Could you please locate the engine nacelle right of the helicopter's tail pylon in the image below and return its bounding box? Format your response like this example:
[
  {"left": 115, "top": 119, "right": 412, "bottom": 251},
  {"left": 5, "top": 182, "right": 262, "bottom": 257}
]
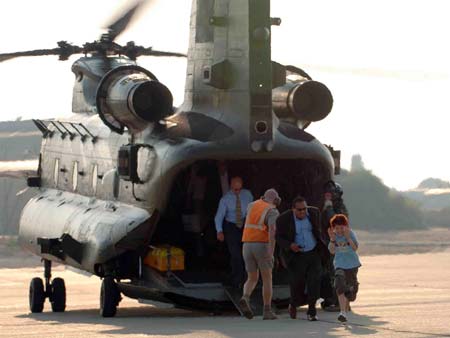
[{"left": 272, "top": 79, "right": 333, "bottom": 125}]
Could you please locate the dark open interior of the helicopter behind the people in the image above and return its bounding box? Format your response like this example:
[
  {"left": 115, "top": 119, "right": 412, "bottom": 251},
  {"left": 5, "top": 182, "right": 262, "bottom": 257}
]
[{"left": 151, "top": 159, "right": 328, "bottom": 283}]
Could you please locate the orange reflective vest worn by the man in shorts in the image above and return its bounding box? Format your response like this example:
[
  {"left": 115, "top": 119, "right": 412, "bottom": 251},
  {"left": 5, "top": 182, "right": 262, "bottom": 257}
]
[{"left": 242, "top": 199, "right": 275, "bottom": 243}]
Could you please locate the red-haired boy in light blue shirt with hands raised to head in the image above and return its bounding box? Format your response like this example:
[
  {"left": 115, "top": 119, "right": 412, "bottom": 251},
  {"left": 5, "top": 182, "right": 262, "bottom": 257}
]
[{"left": 328, "top": 214, "right": 361, "bottom": 323}]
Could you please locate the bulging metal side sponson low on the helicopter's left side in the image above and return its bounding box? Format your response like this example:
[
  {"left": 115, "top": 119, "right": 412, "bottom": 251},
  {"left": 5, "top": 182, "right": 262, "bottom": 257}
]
[{"left": 19, "top": 189, "right": 150, "bottom": 273}]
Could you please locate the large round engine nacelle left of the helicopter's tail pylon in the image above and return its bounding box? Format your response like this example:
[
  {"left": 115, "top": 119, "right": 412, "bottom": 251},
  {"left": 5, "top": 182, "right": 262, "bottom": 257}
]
[{"left": 97, "top": 65, "right": 173, "bottom": 134}]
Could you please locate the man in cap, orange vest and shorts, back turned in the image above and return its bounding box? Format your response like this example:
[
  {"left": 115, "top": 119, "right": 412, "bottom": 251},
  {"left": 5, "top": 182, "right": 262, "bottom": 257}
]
[{"left": 239, "top": 189, "right": 281, "bottom": 319}]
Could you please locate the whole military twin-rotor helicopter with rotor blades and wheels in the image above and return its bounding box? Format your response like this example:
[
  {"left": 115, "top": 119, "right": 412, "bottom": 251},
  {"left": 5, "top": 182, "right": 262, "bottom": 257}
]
[{"left": 0, "top": 0, "right": 340, "bottom": 317}]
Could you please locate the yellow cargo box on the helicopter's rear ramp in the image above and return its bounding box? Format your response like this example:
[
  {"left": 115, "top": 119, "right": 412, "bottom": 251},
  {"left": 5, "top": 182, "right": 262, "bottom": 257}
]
[{"left": 144, "top": 245, "right": 184, "bottom": 271}]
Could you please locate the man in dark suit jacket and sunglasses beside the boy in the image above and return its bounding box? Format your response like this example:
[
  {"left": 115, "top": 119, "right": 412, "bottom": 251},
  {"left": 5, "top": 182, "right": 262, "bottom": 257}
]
[{"left": 276, "top": 196, "right": 328, "bottom": 321}]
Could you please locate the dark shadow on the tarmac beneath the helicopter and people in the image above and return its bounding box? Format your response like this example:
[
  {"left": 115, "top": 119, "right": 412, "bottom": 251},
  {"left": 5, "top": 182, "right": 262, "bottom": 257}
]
[{"left": 17, "top": 306, "right": 386, "bottom": 338}]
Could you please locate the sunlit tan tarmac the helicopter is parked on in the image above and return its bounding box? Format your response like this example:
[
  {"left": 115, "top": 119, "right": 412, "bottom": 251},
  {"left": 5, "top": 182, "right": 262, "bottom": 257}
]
[{"left": 0, "top": 251, "right": 450, "bottom": 338}]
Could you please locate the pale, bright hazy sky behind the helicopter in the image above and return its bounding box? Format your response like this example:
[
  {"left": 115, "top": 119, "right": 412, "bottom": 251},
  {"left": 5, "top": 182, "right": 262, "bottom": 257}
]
[{"left": 0, "top": 0, "right": 450, "bottom": 190}]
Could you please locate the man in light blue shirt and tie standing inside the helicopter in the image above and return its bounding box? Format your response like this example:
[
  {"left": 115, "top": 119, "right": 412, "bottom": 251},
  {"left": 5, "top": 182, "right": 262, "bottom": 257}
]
[{"left": 214, "top": 177, "right": 253, "bottom": 288}]
